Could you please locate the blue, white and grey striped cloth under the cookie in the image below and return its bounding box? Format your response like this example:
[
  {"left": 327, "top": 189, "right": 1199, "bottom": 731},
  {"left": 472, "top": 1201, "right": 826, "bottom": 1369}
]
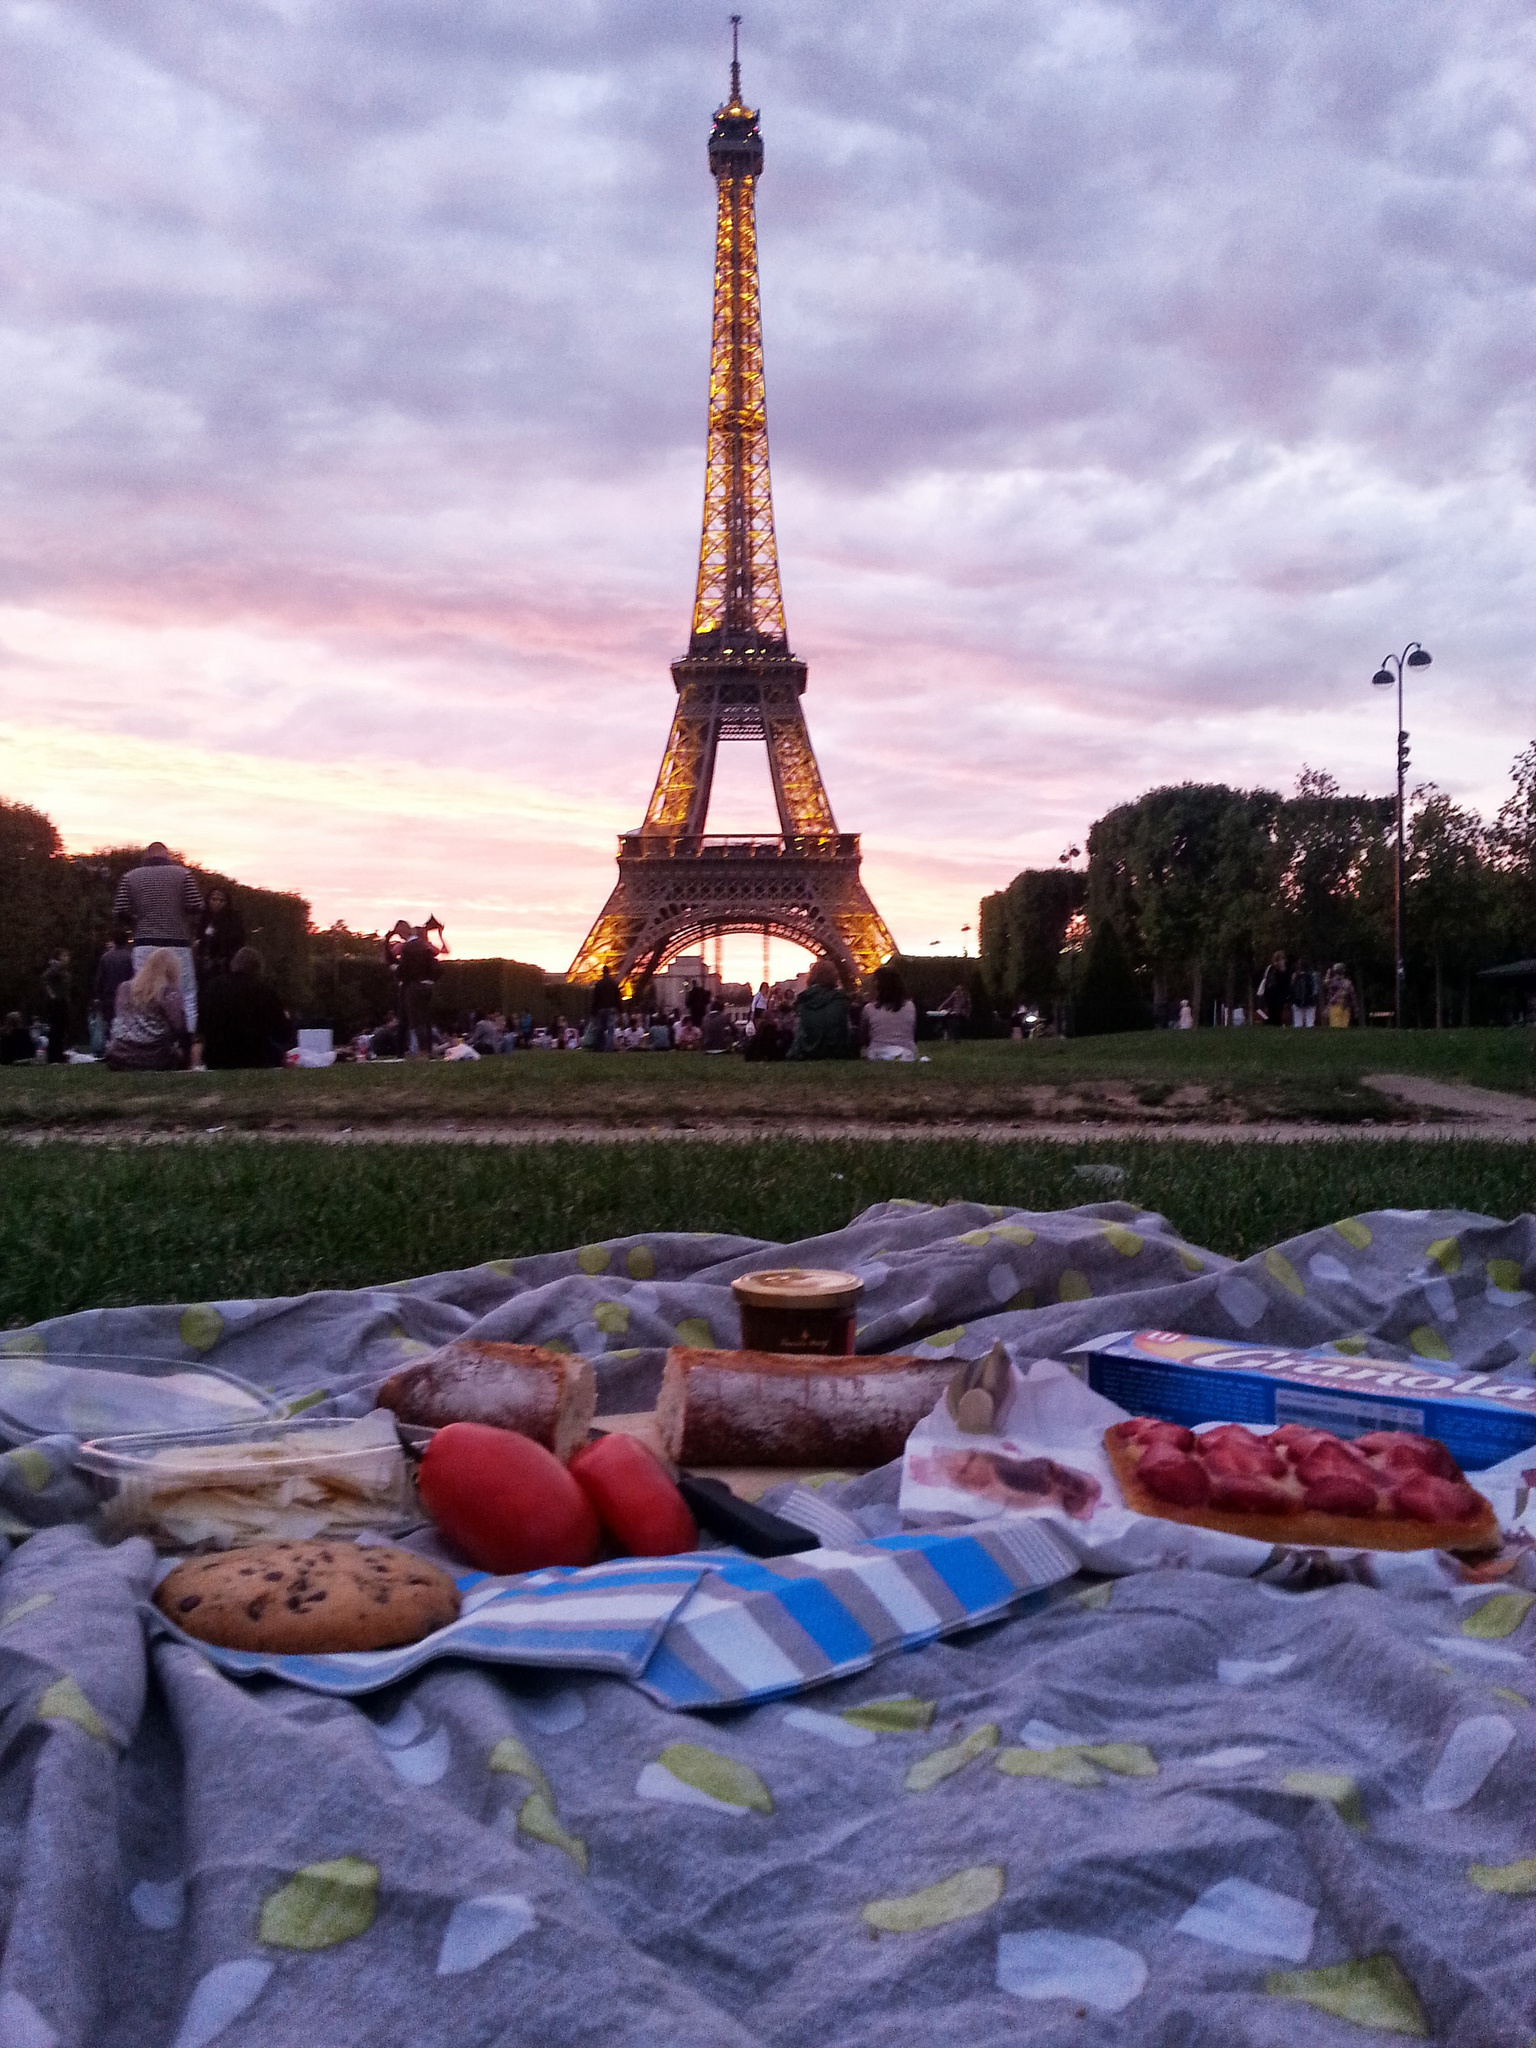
[{"left": 165, "top": 1516, "right": 1077, "bottom": 1708}]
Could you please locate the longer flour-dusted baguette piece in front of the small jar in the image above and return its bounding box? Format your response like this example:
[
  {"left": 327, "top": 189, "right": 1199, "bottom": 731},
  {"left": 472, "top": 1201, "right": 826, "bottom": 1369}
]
[{"left": 655, "top": 1350, "right": 954, "bottom": 1468}]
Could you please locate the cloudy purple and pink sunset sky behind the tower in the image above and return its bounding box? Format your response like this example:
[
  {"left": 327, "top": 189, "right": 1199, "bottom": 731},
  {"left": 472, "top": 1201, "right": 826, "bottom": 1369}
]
[{"left": 0, "top": 0, "right": 1536, "bottom": 967}]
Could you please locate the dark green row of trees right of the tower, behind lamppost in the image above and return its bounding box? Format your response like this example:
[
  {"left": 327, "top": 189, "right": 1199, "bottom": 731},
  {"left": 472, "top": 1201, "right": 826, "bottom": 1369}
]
[{"left": 981, "top": 741, "right": 1536, "bottom": 1030}]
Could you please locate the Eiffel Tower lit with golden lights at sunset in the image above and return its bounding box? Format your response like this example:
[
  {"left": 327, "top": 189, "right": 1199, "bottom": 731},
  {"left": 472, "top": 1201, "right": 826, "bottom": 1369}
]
[{"left": 567, "top": 14, "right": 895, "bottom": 991}]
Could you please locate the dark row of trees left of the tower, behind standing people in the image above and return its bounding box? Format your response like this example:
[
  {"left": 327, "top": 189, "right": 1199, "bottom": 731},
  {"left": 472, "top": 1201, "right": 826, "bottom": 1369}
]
[{"left": 0, "top": 797, "right": 565, "bottom": 1038}]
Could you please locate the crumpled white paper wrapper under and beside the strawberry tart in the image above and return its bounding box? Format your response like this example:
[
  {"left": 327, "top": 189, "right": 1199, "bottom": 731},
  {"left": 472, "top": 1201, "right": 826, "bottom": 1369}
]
[{"left": 901, "top": 1358, "right": 1536, "bottom": 1589}]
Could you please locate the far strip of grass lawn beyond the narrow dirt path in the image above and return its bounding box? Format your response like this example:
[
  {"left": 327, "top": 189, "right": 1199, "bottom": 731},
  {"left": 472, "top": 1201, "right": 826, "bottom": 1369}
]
[{"left": 0, "top": 1030, "right": 1536, "bottom": 1130}]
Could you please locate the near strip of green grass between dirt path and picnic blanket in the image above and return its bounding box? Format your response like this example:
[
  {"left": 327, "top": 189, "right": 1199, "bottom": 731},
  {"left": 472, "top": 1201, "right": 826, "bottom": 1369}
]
[{"left": 0, "top": 1138, "right": 1536, "bottom": 1327}]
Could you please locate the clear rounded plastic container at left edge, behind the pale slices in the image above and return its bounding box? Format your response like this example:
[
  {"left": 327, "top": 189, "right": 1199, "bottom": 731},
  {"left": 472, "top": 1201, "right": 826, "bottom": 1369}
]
[{"left": 0, "top": 1352, "right": 279, "bottom": 1444}]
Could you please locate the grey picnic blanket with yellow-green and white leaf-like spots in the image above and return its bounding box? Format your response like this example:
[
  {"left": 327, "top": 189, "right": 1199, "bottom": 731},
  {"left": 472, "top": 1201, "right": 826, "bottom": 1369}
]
[{"left": 0, "top": 1202, "right": 1536, "bottom": 2048}]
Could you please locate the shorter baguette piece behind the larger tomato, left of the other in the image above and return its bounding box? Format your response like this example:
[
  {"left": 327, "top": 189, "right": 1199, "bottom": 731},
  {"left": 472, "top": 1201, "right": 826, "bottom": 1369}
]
[{"left": 379, "top": 1337, "right": 598, "bottom": 1464}]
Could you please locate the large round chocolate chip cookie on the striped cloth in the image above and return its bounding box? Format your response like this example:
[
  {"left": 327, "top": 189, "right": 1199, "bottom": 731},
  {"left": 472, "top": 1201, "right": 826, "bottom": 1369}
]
[{"left": 156, "top": 1536, "right": 459, "bottom": 1657}]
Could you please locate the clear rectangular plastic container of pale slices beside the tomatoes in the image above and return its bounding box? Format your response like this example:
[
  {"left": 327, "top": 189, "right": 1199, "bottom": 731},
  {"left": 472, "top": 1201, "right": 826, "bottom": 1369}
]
[{"left": 76, "top": 1409, "right": 422, "bottom": 1552}]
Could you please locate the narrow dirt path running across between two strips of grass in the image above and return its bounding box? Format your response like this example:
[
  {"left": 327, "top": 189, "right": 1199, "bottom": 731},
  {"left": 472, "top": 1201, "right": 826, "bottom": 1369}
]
[{"left": 0, "top": 1114, "right": 1536, "bottom": 1147}]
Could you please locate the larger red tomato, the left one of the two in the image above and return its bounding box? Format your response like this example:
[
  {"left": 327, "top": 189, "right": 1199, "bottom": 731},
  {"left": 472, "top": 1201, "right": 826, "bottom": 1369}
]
[{"left": 416, "top": 1421, "right": 602, "bottom": 1573}]
